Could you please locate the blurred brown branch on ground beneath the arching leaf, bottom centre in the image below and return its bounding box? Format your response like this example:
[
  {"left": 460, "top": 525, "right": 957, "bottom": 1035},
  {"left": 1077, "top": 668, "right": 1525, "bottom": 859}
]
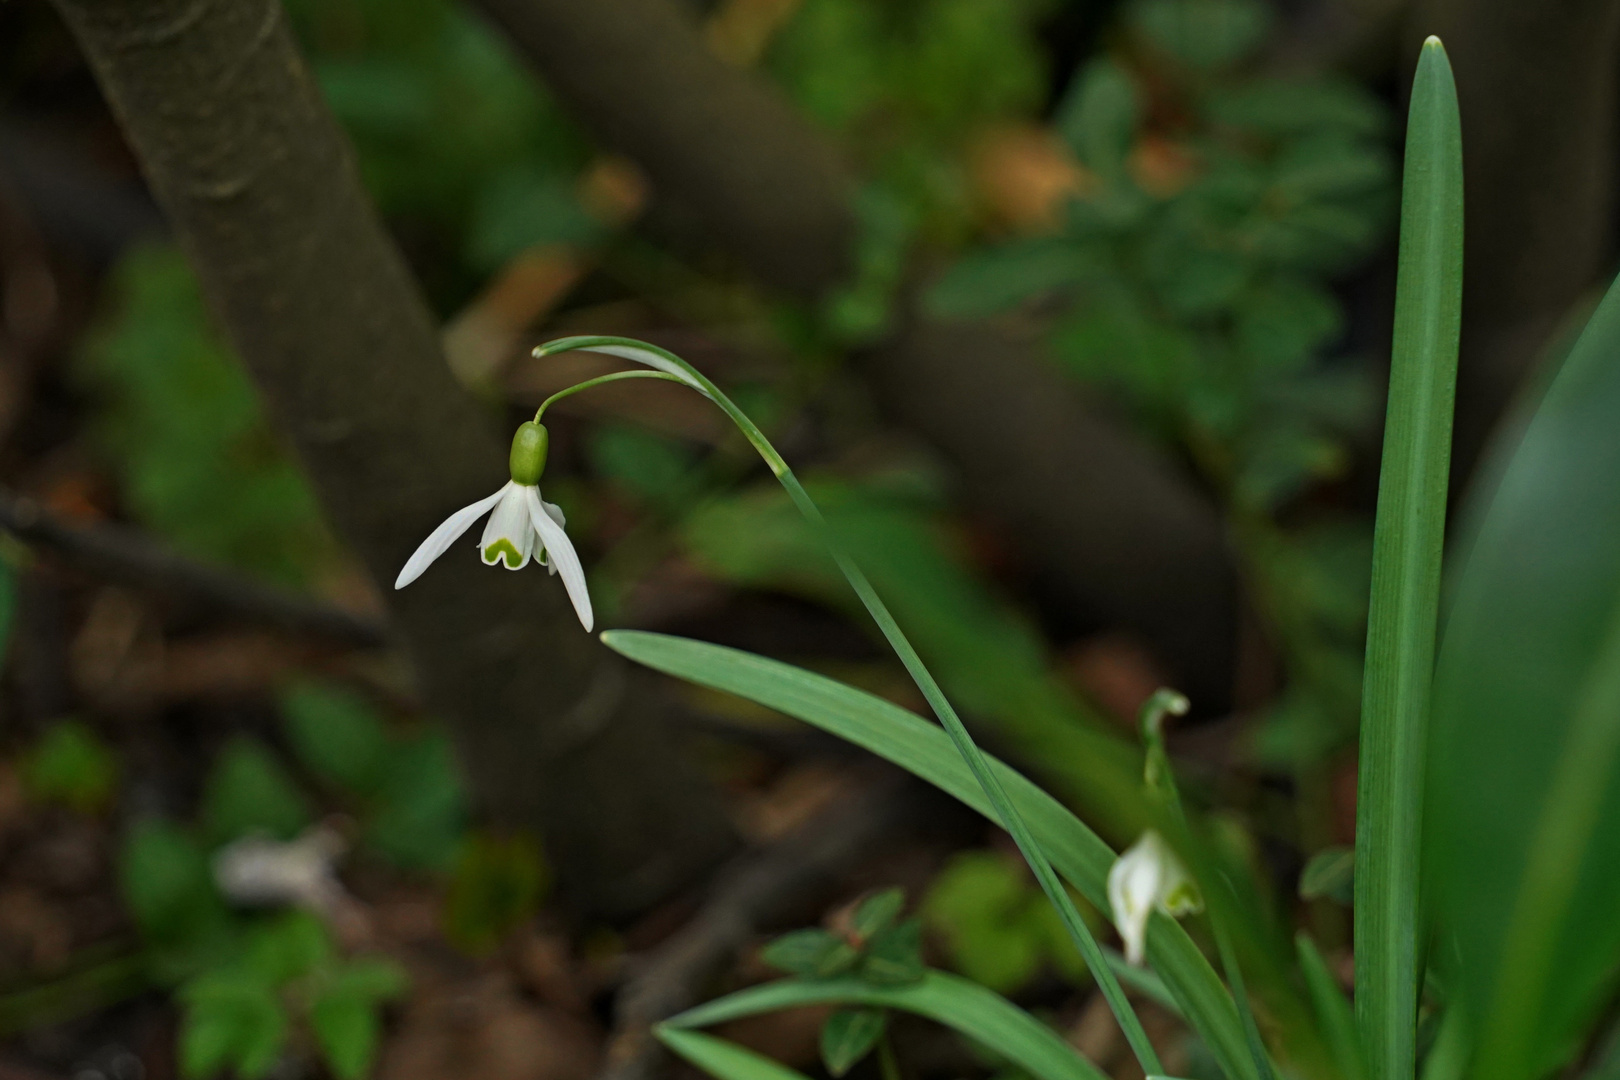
[{"left": 598, "top": 776, "right": 919, "bottom": 1080}]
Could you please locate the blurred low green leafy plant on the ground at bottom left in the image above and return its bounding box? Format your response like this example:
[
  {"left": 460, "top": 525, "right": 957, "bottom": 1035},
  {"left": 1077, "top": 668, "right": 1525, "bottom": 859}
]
[{"left": 122, "top": 683, "right": 443, "bottom": 1080}]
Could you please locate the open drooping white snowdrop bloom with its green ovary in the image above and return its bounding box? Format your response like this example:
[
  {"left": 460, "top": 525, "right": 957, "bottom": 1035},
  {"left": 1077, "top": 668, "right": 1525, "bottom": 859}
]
[{"left": 394, "top": 421, "right": 595, "bottom": 630}]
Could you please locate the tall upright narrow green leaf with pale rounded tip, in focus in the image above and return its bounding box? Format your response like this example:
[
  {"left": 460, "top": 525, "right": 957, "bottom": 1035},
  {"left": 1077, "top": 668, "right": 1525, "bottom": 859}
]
[{"left": 1356, "top": 37, "right": 1463, "bottom": 1080}]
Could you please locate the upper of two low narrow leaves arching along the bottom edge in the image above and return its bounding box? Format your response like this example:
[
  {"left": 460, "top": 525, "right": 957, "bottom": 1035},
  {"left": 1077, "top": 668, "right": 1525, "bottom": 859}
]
[{"left": 666, "top": 972, "right": 1105, "bottom": 1080}]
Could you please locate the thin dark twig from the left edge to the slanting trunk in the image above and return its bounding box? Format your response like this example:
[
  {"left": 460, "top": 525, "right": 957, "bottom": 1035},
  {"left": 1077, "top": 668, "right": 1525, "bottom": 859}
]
[{"left": 0, "top": 489, "right": 390, "bottom": 648}]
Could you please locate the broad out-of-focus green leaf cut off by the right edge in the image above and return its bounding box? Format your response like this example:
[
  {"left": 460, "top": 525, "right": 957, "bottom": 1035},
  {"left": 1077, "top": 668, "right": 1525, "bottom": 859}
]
[{"left": 1426, "top": 270, "right": 1620, "bottom": 1080}]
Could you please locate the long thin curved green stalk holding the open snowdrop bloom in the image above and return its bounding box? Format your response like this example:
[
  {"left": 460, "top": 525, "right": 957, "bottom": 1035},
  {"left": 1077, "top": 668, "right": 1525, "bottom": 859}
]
[{"left": 535, "top": 337, "right": 1165, "bottom": 1077}]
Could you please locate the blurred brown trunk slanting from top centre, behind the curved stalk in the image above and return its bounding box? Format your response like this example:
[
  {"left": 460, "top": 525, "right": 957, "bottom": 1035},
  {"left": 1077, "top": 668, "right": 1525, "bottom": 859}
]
[{"left": 476, "top": 0, "right": 1238, "bottom": 709}]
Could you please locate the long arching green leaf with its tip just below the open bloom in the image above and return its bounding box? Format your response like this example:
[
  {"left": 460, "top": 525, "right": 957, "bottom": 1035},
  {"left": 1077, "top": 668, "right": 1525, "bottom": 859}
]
[{"left": 603, "top": 630, "right": 1256, "bottom": 1080}]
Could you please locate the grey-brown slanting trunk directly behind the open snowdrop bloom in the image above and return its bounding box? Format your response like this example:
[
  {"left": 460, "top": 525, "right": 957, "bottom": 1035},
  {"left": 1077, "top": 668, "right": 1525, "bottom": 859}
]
[{"left": 55, "top": 0, "right": 729, "bottom": 915}]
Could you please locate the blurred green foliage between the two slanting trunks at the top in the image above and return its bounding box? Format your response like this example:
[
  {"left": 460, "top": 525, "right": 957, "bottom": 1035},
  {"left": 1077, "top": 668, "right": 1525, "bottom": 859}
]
[{"left": 287, "top": 0, "right": 604, "bottom": 297}]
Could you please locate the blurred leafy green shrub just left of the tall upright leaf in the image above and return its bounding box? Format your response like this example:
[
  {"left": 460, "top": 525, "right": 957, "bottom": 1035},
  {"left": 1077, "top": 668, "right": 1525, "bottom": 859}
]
[{"left": 930, "top": 0, "right": 1395, "bottom": 771}]
